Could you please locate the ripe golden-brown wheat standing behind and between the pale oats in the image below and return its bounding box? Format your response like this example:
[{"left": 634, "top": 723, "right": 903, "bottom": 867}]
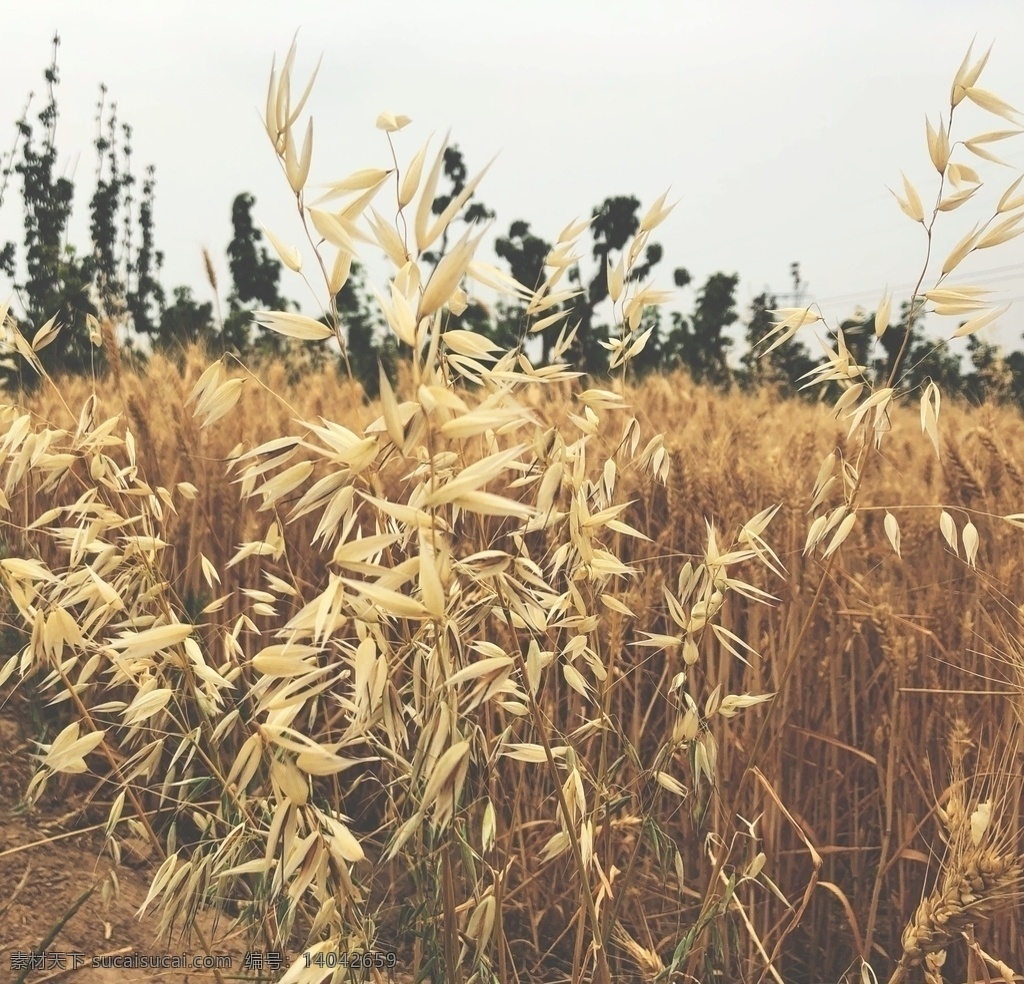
[{"left": 2, "top": 353, "right": 1024, "bottom": 980}]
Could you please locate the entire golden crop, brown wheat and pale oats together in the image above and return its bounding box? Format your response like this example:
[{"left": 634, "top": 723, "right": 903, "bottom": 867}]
[{"left": 0, "top": 30, "right": 1024, "bottom": 984}]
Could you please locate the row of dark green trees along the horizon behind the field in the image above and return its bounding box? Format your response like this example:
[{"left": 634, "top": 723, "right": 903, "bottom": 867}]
[{"left": 0, "top": 37, "right": 1024, "bottom": 408}]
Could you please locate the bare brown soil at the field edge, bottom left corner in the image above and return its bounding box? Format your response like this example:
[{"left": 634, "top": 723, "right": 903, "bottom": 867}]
[{"left": 0, "top": 686, "right": 260, "bottom": 984}]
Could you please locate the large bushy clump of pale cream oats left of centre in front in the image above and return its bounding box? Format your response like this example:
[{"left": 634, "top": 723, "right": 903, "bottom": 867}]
[{"left": 2, "top": 32, "right": 780, "bottom": 984}]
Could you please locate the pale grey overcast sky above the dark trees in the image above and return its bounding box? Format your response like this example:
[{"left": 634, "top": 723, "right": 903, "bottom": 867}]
[{"left": 0, "top": 0, "right": 1024, "bottom": 364}]
